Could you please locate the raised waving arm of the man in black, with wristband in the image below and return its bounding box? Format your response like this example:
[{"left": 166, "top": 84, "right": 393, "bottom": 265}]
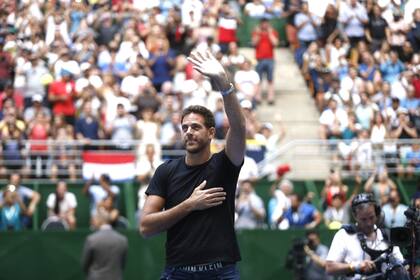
[{"left": 188, "top": 51, "right": 245, "bottom": 166}]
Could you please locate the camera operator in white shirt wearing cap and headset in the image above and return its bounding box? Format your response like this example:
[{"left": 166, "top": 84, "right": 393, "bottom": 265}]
[{"left": 326, "top": 193, "right": 403, "bottom": 279}]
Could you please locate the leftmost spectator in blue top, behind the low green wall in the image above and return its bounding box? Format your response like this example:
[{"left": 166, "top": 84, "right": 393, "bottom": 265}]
[{"left": 0, "top": 185, "right": 26, "bottom": 231}]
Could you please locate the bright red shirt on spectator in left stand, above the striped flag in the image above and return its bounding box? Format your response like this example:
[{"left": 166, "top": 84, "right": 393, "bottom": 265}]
[{"left": 49, "top": 80, "right": 76, "bottom": 116}]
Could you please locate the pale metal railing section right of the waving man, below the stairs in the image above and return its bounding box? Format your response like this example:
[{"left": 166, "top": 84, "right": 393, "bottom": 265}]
[{"left": 258, "top": 138, "right": 420, "bottom": 179}]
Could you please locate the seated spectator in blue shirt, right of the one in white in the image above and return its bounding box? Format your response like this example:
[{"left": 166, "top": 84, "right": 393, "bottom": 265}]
[{"left": 279, "top": 194, "right": 321, "bottom": 229}]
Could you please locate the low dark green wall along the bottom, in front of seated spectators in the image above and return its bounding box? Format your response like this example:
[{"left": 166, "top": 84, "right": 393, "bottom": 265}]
[{"left": 0, "top": 230, "right": 334, "bottom": 280}]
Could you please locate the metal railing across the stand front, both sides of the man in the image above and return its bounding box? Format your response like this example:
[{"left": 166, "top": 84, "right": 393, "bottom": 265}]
[{"left": 0, "top": 139, "right": 420, "bottom": 182}]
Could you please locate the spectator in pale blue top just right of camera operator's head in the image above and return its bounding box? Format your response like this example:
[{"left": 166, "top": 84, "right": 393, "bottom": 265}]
[{"left": 382, "top": 190, "right": 408, "bottom": 228}]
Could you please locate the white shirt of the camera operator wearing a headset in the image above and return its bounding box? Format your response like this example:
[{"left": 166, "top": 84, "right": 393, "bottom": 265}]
[{"left": 326, "top": 229, "right": 403, "bottom": 279}]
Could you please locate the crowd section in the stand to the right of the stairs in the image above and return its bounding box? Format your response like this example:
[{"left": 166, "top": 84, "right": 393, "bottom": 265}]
[{"left": 287, "top": 0, "right": 420, "bottom": 177}]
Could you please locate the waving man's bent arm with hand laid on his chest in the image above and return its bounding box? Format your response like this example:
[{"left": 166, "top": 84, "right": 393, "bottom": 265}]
[{"left": 139, "top": 181, "right": 226, "bottom": 237}]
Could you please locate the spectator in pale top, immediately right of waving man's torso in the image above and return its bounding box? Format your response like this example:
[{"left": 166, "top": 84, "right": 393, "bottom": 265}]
[{"left": 235, "top": 181, "right": 265, "bottom": 229}]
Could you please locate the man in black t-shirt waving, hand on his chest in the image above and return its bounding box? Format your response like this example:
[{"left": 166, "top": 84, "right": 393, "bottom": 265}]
[{"left": 140, "top": 51, "right": 245, "bottom": 279}]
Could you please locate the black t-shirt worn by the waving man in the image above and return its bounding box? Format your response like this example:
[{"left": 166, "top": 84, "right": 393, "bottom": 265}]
[{"left": 146, "top": 150, "right": 241, "bottom": 265}]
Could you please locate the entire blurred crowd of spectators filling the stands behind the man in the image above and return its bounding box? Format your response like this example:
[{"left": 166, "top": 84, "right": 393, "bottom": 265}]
[{"left": 0, "top": 0, "right": 420, "bottom": 232}]
